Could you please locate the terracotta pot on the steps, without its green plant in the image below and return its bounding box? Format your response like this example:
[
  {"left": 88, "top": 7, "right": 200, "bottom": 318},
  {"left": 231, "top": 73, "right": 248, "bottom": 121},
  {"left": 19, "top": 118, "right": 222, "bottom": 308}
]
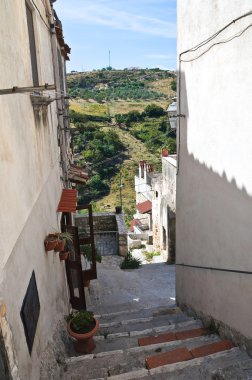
[{"left": 67, "top": 318, "right": 99, "bottom": 354}]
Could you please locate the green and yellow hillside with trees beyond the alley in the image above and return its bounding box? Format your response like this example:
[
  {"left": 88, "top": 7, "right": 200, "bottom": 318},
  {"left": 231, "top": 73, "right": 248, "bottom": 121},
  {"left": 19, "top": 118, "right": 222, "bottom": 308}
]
[{"left": 68, "top": 69, "right": 176, "bottom": 222}]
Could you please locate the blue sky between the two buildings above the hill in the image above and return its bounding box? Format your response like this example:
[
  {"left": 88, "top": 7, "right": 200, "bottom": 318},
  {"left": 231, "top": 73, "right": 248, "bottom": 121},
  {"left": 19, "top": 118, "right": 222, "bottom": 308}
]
[{"left": 54, "top": 0, "right": 176, "bottom": 72}]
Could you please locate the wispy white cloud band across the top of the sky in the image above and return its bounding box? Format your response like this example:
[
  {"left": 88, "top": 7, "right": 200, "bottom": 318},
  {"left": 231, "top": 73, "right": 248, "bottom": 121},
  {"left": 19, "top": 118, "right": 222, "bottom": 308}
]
[{"left": 56, "top": 0, "right": 176, "bottom": 38}]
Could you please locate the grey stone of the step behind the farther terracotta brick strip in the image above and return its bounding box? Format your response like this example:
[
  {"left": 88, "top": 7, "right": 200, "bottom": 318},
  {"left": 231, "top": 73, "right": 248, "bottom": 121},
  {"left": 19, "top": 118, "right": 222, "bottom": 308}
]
[{"left": 93, "top": 320, "right": 202, "bottom": 353}]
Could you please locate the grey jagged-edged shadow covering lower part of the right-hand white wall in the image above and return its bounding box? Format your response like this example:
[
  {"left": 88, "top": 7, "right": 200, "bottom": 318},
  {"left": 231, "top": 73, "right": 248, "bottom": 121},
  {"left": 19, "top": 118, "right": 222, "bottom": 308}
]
[{"left": 176, "top": 69, "right": 252, "bottom": 344}]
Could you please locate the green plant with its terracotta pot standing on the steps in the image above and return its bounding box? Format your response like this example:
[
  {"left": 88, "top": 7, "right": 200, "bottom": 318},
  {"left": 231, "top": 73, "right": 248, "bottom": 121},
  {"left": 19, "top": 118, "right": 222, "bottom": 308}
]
[{"left": 65, "top": 310, "right": 99, "bottom": 354}]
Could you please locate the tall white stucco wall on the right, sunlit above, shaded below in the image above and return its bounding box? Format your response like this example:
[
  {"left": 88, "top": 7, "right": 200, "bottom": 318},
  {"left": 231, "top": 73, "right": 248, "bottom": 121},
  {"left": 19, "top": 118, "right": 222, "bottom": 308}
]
[{"left": 176, "top": 0, "right": 252, "bottom": 338}]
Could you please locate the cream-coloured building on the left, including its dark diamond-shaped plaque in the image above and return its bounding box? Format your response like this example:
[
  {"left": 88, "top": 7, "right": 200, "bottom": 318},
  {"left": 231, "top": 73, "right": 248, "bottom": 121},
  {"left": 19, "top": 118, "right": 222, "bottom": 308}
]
[{"left": 0, "top": 0, "right": 71, "bottom": 380}]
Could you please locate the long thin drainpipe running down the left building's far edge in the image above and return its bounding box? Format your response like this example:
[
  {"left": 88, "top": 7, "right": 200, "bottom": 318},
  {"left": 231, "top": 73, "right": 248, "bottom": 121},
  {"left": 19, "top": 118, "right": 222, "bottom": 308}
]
[{"left": 45, "top": 0, "right": 67, "bottom": 186}]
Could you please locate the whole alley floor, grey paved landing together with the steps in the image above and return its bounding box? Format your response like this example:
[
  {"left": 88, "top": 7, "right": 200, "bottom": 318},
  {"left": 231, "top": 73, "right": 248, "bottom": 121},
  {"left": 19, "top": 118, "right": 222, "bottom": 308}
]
[{"left": 63, "top": 256, "right": 252, "bottom": 380}]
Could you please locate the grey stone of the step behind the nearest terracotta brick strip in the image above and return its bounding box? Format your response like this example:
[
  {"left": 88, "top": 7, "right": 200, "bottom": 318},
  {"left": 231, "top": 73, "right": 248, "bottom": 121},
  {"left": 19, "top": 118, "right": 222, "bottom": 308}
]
[{"left": 63, "top": 335, "right": 220, "bottom": 380}]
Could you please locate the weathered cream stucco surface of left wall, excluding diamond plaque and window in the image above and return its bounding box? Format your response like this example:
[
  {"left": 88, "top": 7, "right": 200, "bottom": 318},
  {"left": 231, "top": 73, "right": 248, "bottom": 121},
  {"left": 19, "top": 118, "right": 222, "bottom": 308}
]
[{"left": 0, "top": 0, "right": 68, "bottom": 380}]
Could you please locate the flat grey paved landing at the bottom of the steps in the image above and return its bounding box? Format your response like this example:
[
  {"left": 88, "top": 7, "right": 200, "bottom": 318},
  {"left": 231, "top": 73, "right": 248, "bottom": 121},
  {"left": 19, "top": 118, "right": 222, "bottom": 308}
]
[{"left": 87, "top": 256, "right": 175, "bottom": 314}]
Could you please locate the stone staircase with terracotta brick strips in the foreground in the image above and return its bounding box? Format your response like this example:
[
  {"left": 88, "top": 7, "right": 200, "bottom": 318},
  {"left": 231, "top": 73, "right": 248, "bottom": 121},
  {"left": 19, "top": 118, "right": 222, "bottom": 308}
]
[{"left": 63, "top": 306, "right": 252, "bottom": 380}]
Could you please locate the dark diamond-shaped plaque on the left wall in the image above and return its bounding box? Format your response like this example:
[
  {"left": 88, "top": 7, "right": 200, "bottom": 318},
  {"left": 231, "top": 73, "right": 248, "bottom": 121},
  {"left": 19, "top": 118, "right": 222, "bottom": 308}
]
[{"left": 20, "top": 271, "right": 40, "bottom": 354}]
